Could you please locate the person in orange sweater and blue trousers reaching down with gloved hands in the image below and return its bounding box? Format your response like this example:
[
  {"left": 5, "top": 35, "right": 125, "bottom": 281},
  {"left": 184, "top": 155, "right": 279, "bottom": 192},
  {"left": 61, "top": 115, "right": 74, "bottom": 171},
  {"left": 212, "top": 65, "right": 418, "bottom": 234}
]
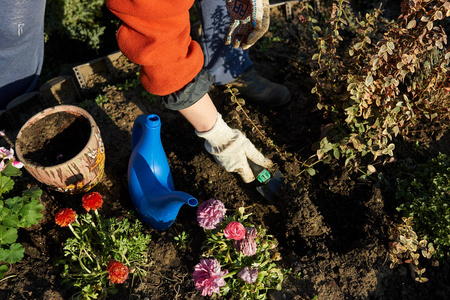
[{"left": 106, "top": 0, "right": 291, "bottom": 182}]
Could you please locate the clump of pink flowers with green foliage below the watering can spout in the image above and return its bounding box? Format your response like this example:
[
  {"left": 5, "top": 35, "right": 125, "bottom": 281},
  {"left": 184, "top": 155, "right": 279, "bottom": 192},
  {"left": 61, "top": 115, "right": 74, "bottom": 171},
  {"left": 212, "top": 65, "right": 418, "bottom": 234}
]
[{"left": 193, "top": 199, "right": 283, "bottom": 299}]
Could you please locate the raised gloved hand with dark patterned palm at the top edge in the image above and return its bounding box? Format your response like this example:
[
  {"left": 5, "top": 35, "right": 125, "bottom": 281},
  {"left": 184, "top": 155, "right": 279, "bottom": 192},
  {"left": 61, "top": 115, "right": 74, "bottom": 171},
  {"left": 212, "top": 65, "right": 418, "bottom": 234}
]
[{"left": 225, "top": 0, "right": 270, "bottom": 50}]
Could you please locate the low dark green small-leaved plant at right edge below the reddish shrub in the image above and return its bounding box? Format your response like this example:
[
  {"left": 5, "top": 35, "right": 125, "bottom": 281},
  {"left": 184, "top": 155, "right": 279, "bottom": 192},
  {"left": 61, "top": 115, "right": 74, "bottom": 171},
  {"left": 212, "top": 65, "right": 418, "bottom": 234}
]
[{"left": 396, "top": 153, "right": 450, "bottom": 259}]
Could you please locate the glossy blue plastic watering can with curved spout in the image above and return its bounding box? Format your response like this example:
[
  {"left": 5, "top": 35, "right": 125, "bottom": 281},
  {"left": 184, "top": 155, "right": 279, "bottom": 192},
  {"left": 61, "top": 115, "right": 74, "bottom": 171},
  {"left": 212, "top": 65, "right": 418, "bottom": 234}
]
[{"left": 128, "top": 114, "right": 198, "bottom": 230}]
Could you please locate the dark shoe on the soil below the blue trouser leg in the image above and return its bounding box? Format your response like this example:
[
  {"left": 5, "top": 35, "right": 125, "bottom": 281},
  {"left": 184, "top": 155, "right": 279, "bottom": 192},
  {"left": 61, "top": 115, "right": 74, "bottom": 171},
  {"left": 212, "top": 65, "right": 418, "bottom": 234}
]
[{"left": 230, "top": 66, "right": 291, "bottom": 107}]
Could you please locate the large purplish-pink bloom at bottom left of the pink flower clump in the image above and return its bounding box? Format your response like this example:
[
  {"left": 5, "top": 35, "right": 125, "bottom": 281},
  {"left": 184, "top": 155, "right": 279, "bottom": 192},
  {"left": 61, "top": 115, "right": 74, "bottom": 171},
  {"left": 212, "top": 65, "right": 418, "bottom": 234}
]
[{"left": 192, "top": 258, "right": 228, "bottom": 296}]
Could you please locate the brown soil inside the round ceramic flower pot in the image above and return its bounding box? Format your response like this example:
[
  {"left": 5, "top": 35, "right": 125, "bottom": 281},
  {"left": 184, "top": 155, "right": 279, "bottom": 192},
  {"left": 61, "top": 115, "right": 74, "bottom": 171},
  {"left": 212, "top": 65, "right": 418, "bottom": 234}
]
[{"left": 18, "top": 112, "right": 91, "bottom": 167}]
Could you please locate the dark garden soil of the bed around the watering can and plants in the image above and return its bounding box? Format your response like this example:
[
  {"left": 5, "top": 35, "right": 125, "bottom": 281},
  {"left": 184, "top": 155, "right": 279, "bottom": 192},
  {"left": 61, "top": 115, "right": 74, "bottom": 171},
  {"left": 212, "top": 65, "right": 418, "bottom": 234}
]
[{"left": 0, "top": 2, "right": 450, "bottom": 300}]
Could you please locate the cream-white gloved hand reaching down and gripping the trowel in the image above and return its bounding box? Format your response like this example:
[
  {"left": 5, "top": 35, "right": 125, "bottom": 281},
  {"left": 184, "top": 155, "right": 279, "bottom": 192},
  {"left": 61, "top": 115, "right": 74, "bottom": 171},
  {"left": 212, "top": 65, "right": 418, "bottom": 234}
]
[{"left": 195, "top": 113, "right": 272, "bottom": 183}]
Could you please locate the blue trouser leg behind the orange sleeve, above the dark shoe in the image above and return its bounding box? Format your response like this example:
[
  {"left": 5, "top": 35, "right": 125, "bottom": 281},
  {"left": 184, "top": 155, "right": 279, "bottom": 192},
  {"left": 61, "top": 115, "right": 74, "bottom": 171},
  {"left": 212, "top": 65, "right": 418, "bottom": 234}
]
[{"left": 196, "top": 0, "right": 252, "bottom": 85}]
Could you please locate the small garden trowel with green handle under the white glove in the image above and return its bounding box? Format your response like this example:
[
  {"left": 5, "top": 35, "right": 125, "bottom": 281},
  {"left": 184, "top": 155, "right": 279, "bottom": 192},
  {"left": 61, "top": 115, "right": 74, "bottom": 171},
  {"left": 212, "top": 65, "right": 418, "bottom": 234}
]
[{"left": 247, "top": 159, "right": 284, "bottom": 204}]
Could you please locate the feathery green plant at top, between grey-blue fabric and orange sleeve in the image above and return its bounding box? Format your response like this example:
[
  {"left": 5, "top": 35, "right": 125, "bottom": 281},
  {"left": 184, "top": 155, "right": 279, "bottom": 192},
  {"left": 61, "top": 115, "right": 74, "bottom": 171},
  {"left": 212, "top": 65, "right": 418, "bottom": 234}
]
[{"left": 44, "top": 0, "right": 105, "bottom": 49}]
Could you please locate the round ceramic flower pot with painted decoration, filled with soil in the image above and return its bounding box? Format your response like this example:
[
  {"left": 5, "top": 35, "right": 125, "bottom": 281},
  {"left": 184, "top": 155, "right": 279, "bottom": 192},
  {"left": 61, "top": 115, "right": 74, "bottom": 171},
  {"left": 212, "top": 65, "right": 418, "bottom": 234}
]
[{"left": 16, "top": 105, "right": 105, "bottom": 194}]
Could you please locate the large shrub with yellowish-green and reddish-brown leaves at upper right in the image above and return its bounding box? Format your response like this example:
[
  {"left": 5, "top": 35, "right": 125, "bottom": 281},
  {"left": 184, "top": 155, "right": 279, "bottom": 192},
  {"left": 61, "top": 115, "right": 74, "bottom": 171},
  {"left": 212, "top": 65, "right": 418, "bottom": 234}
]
[{"left": 304, "top": 0, "right": 450, "bottom": 169}]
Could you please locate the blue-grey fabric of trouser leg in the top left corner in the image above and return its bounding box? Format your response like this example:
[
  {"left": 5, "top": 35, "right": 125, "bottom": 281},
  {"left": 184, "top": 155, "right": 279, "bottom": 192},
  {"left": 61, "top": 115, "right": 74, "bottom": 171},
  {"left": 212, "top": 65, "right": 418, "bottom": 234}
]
[{"left": 0, "top": 0, "right": 45, "bottom": 109}]
